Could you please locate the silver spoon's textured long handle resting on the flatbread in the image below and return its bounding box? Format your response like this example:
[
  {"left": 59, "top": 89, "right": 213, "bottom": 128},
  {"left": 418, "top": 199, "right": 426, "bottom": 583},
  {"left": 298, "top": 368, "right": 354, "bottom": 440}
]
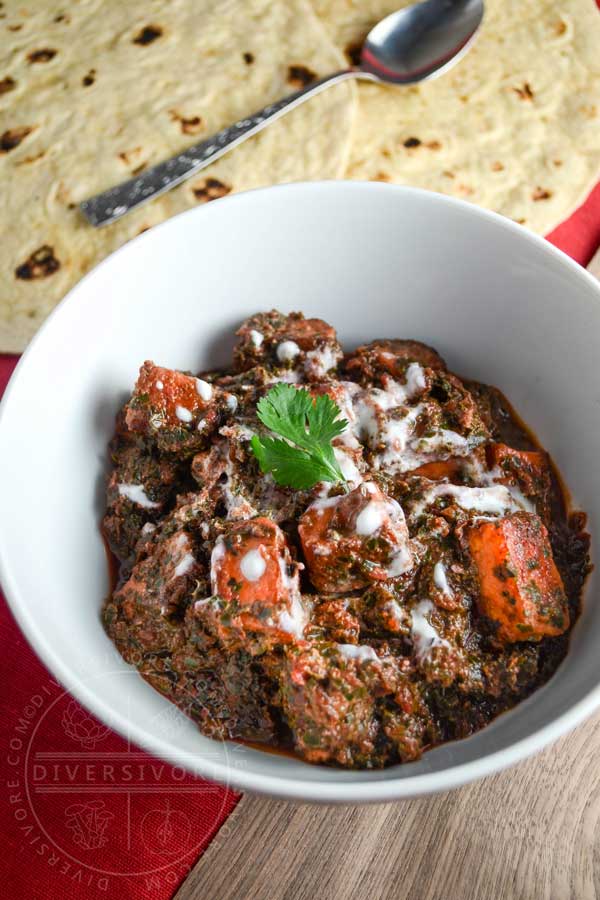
[{"left": 79, "top": 69, "right": 360, "bottom": 227}]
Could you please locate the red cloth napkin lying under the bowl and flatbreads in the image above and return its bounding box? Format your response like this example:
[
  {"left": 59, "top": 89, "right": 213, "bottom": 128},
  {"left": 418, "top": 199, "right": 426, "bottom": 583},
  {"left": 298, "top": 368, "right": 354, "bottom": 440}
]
[{"left": 0, "top": 179, "right": 600, "bottom": 900}]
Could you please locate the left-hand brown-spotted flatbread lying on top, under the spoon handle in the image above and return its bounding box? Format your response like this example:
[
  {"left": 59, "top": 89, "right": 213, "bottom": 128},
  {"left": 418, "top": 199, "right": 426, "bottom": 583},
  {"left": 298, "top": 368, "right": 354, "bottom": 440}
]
[{"left": 0, "top": 0, "right": 355, "bottom": 351}]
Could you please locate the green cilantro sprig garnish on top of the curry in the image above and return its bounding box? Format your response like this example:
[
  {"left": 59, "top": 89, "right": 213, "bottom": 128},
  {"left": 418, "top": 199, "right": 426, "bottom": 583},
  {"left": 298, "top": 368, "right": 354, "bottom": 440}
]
[{"left": 251, "top": 384, "right": 348, "bottom": 490}]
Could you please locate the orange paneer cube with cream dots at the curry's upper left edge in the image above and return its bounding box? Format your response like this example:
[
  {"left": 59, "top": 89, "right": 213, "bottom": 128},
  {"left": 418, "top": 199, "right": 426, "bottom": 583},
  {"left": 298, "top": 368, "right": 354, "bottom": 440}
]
[{"left": 126, "top": 362, "right": 229, "bottom": 450}]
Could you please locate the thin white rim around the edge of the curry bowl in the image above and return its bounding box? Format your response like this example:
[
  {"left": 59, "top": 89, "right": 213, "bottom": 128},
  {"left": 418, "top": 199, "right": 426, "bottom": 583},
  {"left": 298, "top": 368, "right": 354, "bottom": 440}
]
[{"left": 0, "top": 180, "right": 600, "bottom": 804}]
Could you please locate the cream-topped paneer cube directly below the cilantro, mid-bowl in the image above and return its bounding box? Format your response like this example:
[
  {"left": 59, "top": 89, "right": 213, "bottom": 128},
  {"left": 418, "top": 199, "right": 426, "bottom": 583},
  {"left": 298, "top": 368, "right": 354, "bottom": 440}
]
[{"left": 298, "top": 482, "right": 413, "bottom": 593}]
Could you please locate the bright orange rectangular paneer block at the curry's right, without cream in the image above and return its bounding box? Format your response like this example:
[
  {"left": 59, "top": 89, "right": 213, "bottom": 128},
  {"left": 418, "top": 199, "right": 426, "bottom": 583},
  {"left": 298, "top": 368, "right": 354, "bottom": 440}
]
[{"left": 468, "top": 512, "right": 569, "bottom": 643}]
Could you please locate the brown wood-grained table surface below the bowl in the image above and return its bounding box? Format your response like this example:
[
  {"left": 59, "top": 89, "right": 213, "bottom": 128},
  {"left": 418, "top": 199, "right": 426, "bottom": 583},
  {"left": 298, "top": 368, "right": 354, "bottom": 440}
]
[{"left": 175, "top": 251, "right": 600, "bottom": 900}]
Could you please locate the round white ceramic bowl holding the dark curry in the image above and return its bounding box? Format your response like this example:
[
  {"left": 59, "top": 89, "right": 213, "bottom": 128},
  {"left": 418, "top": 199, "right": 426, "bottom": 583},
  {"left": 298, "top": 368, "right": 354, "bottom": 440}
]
[{"left": 0, "top": 182, "right": 600, "bottom": 803}]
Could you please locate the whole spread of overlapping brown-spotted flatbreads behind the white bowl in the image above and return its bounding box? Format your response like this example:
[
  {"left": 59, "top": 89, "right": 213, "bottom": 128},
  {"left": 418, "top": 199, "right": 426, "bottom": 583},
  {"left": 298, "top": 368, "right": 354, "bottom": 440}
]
[{"left": 0, "top": 0, "right": 600, "bottom": 351}]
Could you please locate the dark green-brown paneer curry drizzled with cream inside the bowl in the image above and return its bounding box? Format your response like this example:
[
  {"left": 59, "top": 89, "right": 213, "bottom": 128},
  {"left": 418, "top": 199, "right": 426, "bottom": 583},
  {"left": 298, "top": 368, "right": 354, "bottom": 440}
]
[{"left": 103, "top": 311, "right": 590, "bottom": 768}]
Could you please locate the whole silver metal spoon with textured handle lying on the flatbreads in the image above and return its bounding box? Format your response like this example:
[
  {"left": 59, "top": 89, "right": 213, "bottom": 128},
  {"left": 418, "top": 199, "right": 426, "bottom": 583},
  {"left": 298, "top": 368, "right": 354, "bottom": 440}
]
[{"left": 80, "top": 0, "right": 483, "bottom": 226}]
